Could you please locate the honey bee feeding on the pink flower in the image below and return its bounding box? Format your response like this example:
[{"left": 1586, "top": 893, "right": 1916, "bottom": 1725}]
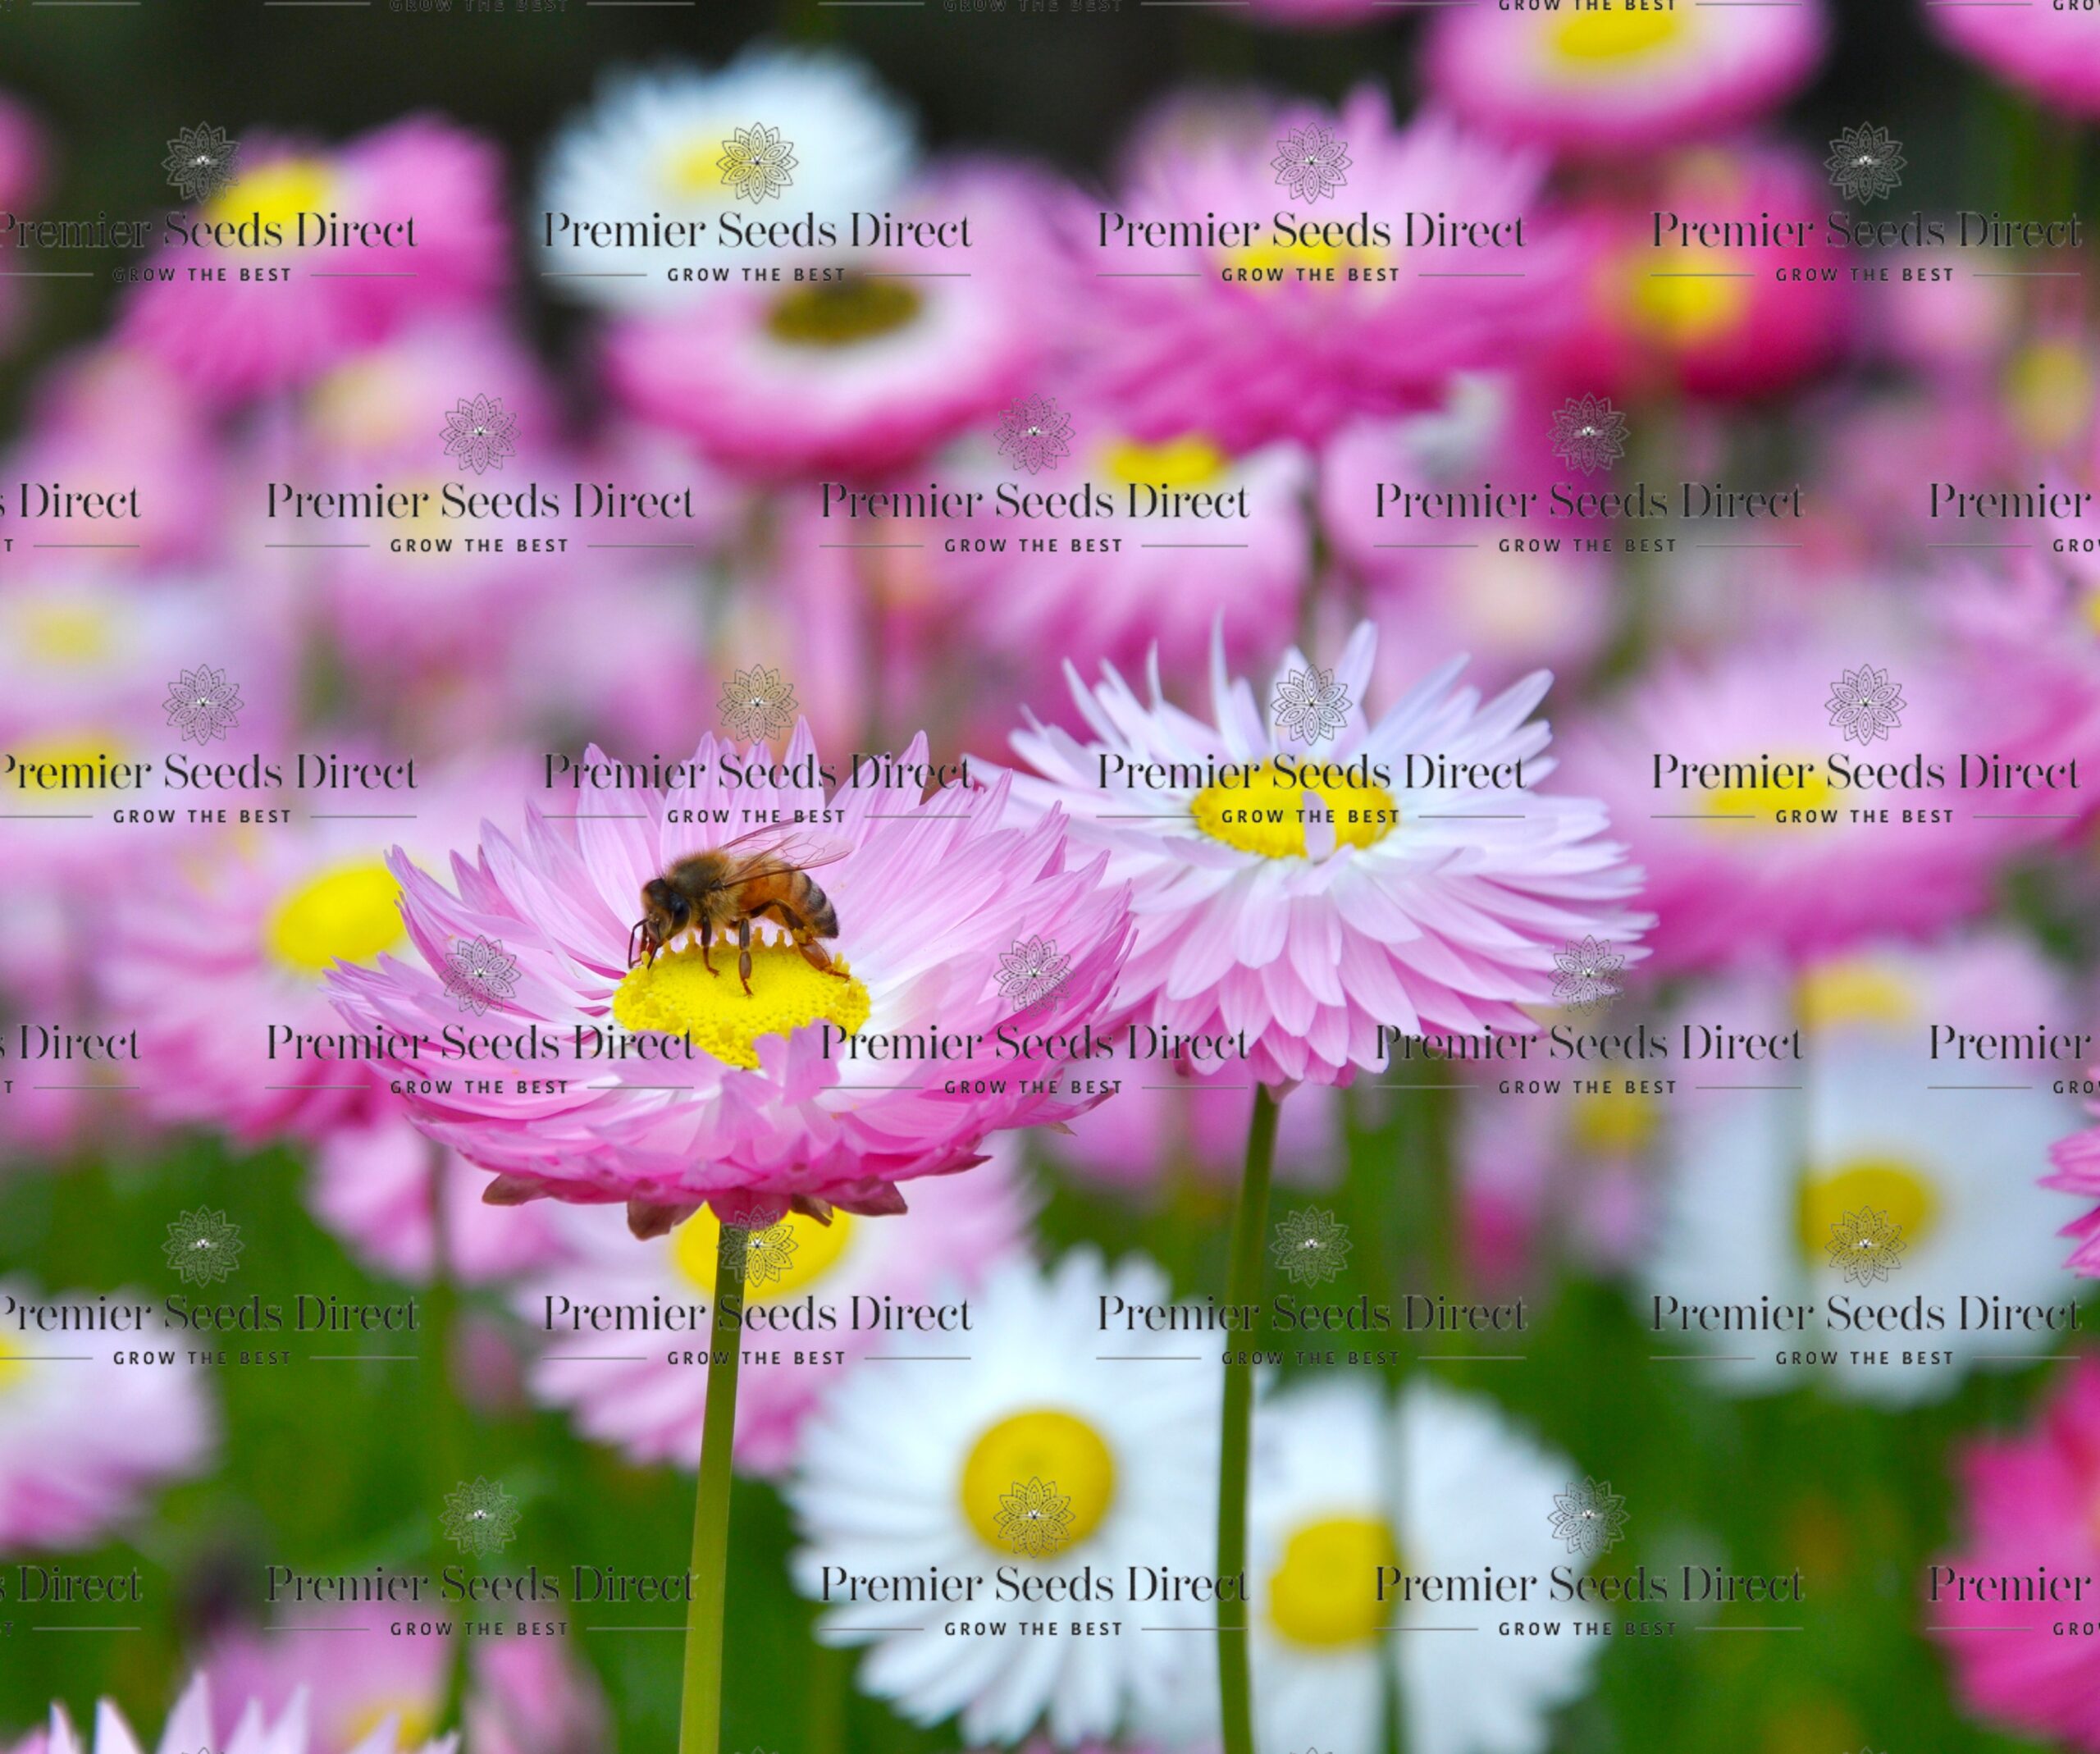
[{"left": 628, "top": 824, "right": 852, "bottom": 993}]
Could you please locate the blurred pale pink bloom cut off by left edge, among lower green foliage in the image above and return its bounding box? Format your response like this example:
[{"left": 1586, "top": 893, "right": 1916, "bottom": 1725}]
[{"left": 0, "top": 1279, "right": 217, "bottom": 1548}]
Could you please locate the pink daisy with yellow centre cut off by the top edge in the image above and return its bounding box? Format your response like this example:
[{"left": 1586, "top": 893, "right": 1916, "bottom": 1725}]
[{"left": 1424, "top": 0, "right": 1829, "bottom": 158}]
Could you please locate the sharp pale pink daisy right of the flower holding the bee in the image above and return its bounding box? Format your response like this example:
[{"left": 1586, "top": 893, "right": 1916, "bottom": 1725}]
[{"left": 1012, "top": 622, "right": 1649, "bottom": 1084}]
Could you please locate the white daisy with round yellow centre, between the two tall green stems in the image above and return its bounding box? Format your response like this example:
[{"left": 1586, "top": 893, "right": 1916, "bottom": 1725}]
[{"left": 788, "top": 1249, "right": 1220, "bottom": 1743}]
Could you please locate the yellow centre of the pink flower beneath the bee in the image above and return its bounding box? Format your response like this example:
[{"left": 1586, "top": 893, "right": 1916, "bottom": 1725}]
[{"left": 614, "top": 943, "right": 874, "bottom": 1071}]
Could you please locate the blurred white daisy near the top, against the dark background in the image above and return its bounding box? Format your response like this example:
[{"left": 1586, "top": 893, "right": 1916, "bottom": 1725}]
[{"left": 536, "top": 48, "right": 915, "bottom": 308}]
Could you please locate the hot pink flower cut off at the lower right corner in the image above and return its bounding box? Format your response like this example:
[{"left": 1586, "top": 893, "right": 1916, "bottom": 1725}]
[{"left": 1930, "top": 1357, "right": 2100, "bottom": 1750}]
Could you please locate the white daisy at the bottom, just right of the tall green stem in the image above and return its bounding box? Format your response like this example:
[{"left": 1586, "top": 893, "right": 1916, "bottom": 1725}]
[{"left": 1248, "top": 1376, "right": 1600, "bottom": 1754}]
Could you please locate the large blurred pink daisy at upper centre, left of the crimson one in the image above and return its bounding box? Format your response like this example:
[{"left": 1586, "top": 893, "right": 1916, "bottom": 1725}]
[{"left": 1065, "top": 86, "right": 1567, "bottom": 452}]
